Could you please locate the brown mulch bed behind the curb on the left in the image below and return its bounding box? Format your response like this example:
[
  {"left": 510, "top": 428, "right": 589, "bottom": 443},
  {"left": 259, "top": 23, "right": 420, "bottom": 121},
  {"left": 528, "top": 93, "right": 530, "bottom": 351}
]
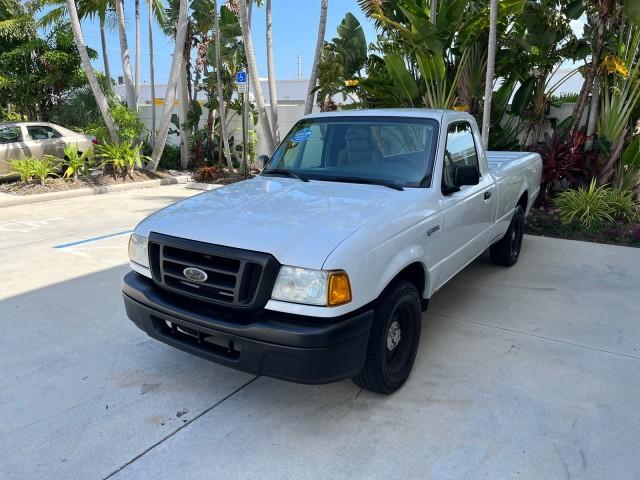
[{"left": 0, "top": 171, "right": 173, "bottom": 195}]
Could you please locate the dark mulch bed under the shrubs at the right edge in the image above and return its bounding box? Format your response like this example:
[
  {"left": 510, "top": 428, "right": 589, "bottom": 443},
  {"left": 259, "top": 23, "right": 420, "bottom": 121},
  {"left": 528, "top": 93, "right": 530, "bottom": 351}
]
[{"left": 525, "top": 206, "right": 640, "bottom": 247}]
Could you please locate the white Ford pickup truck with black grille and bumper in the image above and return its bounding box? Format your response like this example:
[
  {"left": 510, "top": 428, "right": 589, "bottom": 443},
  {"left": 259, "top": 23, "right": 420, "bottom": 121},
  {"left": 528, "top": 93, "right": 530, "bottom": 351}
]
[{"left": 123, "top": 109, "right": 542, "bottom": 393}]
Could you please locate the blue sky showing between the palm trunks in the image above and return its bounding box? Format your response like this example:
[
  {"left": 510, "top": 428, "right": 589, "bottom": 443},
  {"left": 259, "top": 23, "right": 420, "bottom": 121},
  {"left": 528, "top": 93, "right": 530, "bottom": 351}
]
[{"left": 70, "top": 0, "right": 375, "bottom": 83}]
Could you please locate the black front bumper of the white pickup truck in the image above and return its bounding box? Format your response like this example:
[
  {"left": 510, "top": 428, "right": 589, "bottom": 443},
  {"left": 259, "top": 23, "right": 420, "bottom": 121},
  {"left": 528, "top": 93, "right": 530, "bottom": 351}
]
[{"left": 122, "top": 272, "right": 373, "bottom": 384}]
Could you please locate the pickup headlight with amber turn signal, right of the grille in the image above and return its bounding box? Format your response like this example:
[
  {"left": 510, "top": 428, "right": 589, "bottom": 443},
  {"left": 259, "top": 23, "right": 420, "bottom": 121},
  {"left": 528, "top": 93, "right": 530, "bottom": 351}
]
[{"left": 271, "top": 266, "right": 351, "bottom": 307}]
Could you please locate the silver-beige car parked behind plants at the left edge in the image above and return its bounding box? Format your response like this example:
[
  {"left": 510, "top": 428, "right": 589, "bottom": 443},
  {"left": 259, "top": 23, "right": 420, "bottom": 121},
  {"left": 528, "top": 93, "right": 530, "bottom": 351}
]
[{"left": 0, "top": 122, "right": 94, "bottom": 177}]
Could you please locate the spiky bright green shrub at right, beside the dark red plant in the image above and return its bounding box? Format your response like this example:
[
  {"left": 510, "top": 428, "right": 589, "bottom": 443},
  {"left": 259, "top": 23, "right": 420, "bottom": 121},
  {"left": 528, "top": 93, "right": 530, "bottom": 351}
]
[{"left": 554, "top": 179, "right": 637, "bottom": 229}]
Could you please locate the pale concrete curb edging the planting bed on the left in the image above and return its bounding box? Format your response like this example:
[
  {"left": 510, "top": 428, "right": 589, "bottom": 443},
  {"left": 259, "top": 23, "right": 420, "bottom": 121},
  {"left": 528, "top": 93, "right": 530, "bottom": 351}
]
[{"left": 0, "top": 175, "right": 190, "bottom": 208}]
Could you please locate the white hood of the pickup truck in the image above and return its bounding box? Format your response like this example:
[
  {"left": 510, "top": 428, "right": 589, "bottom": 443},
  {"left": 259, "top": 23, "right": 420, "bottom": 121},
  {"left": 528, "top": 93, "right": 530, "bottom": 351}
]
[{"left": 136, "top": 177, "right": 415, "bottom": 269}]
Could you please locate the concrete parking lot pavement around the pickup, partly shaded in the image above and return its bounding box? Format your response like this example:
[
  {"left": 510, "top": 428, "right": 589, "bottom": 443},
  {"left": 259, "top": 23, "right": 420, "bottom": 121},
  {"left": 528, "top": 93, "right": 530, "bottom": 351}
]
[{"left": 0, "top": 186, "right": 640, "bottom": 480}]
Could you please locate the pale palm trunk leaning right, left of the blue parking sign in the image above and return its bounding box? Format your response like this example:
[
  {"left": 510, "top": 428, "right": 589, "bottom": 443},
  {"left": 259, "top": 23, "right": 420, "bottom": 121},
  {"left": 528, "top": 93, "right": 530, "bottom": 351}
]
[{"left": 148, "top": 0, "right": 188, "bottom": 171}]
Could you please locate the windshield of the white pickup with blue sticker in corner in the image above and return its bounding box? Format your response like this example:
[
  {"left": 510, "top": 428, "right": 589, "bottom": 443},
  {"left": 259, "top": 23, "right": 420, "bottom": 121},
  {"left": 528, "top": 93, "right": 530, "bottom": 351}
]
[{"left": 263, "top": 117, "right": 438, "bottom": 187}]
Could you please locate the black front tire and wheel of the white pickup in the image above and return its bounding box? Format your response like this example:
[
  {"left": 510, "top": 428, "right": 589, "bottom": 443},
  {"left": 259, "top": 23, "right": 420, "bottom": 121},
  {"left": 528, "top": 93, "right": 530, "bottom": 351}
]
[{"left": 353, "top": 281, "right": 422, "bottom": 394}]
